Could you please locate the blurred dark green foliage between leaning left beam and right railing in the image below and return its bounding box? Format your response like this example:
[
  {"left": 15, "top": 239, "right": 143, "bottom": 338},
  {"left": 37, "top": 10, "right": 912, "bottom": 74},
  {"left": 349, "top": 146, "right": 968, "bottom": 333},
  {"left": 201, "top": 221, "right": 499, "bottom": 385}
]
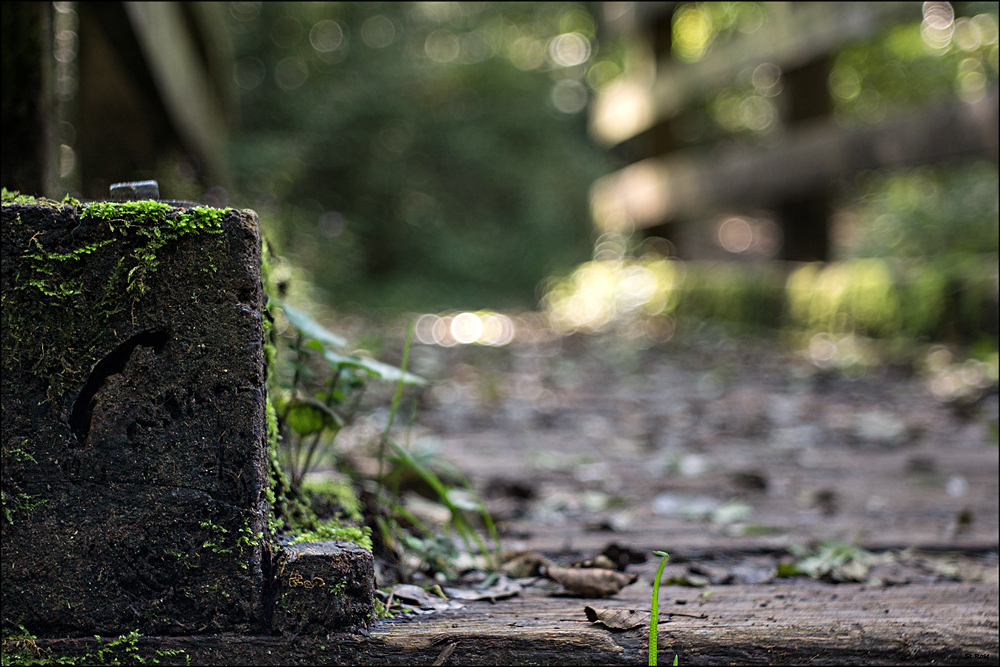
[{"left": 232, "top": 3, "right": 609, "bottom": 309}]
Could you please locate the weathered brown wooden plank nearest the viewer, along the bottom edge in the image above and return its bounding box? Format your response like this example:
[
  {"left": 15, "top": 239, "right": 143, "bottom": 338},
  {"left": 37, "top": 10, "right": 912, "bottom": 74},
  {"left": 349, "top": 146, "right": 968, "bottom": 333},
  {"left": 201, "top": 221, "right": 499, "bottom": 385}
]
[{"left": 27, "top": 579, "right": 998, "bottom": 665}]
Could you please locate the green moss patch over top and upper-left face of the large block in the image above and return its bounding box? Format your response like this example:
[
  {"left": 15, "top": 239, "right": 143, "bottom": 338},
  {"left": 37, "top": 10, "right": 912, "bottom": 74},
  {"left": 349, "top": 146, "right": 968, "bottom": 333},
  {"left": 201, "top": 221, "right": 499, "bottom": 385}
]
[{"left": 2, "top": 200, "right": 231, "bottom": 399}]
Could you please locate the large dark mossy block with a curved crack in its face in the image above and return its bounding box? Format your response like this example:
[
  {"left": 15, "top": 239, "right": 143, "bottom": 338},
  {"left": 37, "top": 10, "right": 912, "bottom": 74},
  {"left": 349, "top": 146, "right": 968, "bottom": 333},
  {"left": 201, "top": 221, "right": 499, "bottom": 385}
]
[{"left": 0, "top": 200, "right": 270, "bottom": 636}]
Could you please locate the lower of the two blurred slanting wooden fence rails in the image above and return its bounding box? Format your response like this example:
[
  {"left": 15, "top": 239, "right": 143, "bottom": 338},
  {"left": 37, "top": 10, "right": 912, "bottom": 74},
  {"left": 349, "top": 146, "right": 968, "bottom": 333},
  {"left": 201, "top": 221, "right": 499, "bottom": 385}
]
[{"left": 591, "top": 86, "right": 1000, "bottom": 228}]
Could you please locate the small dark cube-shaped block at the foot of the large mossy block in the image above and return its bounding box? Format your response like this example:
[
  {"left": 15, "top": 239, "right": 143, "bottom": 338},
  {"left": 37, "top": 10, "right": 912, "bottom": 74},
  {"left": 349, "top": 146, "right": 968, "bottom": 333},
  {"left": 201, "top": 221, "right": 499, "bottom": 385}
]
[{"left": 273, "top": 541, "right": 375, "bottom": 637}]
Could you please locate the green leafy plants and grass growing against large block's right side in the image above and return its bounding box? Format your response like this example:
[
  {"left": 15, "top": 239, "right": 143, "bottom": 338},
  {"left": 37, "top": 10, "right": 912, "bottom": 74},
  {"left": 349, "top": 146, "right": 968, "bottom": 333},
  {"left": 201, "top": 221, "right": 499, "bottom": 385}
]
[{"left": 264, "top": 247, "right": 500, "bottom": 578}]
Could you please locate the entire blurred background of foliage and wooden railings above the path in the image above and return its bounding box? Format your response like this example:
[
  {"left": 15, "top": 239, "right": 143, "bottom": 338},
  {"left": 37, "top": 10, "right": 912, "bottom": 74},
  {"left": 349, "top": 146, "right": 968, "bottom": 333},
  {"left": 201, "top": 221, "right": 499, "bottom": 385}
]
[{"left": 3, "top": 2, "right": 998, "bottom": 340}]
